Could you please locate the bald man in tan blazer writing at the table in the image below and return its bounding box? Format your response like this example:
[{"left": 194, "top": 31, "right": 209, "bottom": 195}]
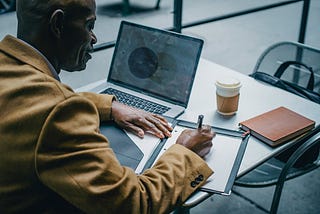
[{"left": 0, "top": 0, "right": 214, "bottom": 213}]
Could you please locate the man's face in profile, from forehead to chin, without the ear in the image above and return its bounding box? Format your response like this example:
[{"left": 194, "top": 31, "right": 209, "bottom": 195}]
[{"left": 59, "top": 0, "right": 97, "bottom": 71}]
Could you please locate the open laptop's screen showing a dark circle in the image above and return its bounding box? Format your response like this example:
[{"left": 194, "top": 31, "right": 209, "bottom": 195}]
[{"left": 108, "top": 21, "right": 203, "bottom": 107}]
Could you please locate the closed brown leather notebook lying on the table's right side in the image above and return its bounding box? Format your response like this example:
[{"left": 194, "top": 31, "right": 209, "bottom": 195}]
[{"left": 239, "top": 107, "right": 315, "bottom": 147}]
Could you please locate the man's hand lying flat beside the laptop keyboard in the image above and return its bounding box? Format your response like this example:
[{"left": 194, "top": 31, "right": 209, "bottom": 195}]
[{"left": 112, "top": 101, "right": 172, "bottom": 138}]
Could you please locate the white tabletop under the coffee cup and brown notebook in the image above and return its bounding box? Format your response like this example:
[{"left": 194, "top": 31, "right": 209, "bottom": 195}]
[{"left": 77, "top": 59, "right": 320, "bottom": 211}]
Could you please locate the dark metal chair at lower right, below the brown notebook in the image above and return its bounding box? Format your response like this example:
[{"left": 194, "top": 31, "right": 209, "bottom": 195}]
[{"left": 234, "top": 126, "right": 320, "bottom": 213}]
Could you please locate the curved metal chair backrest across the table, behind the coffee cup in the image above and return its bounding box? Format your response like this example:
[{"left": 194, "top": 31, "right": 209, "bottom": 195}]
[{"left": 251, "top": 41, "right": 320, "bottom": 102}]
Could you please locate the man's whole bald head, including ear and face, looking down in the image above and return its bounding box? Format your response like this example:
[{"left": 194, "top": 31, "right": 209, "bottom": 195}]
[{"left": 17, "top": 0, "right": 97, "bottom": 72}]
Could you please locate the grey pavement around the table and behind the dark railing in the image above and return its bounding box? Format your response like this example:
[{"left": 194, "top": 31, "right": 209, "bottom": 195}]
[{"left": 0, "top": 0, "right": 320, "bottom": 214}]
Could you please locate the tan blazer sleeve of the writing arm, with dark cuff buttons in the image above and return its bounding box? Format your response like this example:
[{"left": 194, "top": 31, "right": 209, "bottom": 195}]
[{"left": 35, "top": 96, "right": 212, "bottom": 213}]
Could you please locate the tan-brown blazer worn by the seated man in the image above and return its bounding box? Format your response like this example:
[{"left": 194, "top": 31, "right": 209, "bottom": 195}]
[{"left": 0, "top": 36, "right": 212, "bottom": 213}]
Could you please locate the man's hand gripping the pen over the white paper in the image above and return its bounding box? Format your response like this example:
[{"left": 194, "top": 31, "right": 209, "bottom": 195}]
[{"left": 176, "top": 125, "right": 216, "bottom": 158}]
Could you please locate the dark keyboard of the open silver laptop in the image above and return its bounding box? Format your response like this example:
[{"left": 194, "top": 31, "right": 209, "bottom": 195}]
[{"left": 102, "top": 88, "right": 170, "bottom": 114}]
